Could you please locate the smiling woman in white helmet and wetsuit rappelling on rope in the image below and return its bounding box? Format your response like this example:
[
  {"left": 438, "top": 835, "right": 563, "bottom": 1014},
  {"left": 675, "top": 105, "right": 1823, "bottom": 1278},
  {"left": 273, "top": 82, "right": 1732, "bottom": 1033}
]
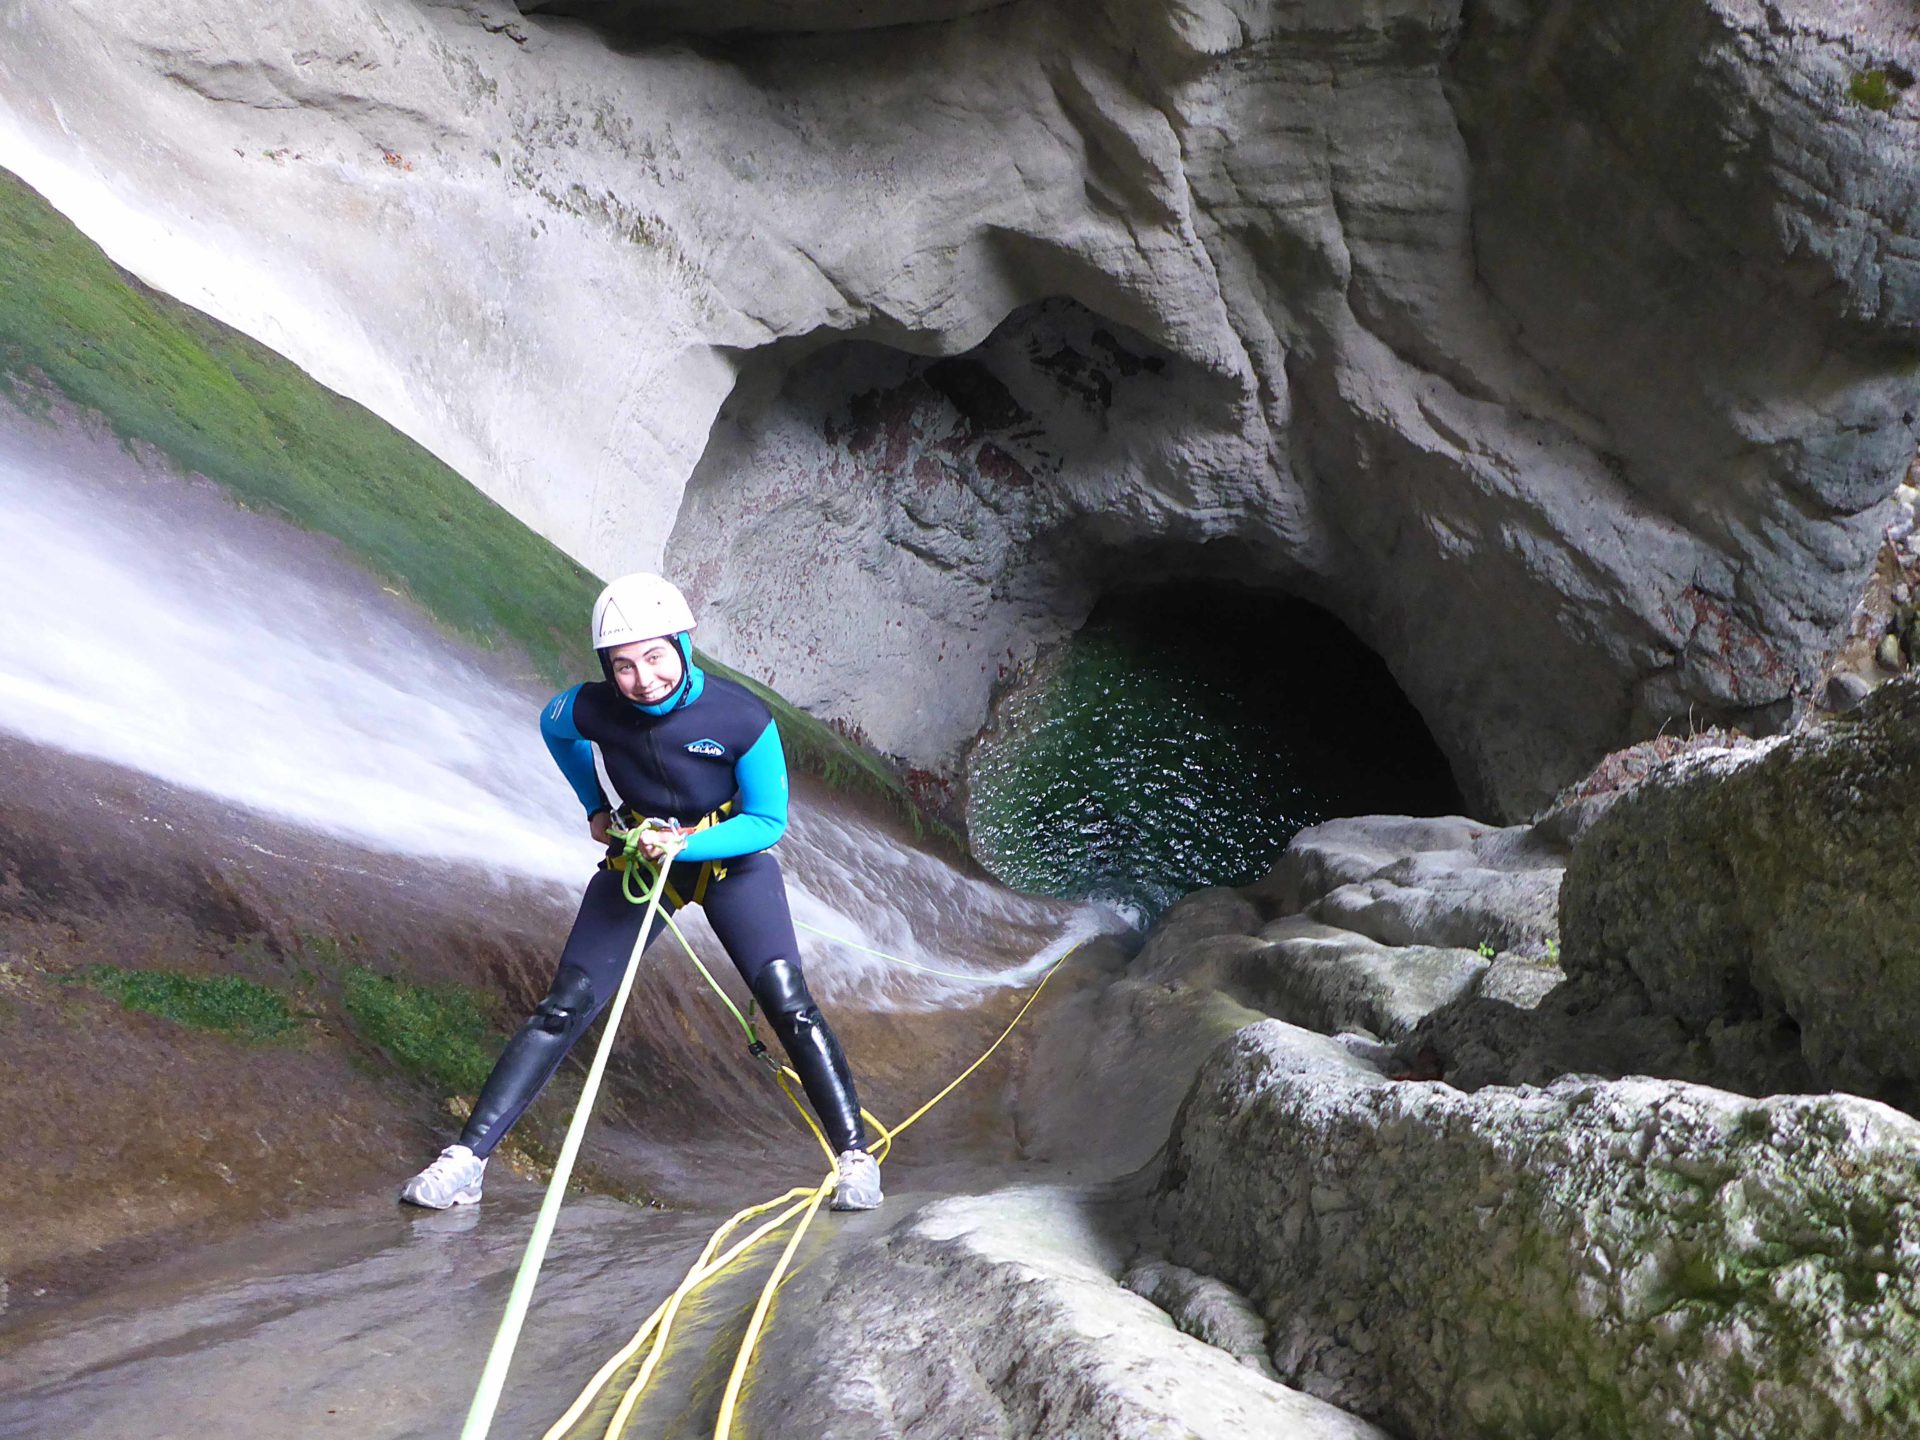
[{"left": 399, "top": 574, "right": 883, "bottom": 1210}]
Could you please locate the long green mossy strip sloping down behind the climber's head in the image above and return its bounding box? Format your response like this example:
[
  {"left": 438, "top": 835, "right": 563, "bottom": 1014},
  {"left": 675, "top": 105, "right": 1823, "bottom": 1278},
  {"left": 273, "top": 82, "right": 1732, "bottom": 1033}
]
[{"left": 0, "top": 169, "right": 958, "bottom": 845}]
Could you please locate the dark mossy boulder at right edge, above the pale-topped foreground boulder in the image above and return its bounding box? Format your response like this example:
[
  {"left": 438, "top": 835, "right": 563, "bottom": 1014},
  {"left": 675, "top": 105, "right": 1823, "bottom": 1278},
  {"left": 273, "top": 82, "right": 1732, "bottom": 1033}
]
[{"left": 1561, "top": 680, "right": 1920, "bottom": 1102}]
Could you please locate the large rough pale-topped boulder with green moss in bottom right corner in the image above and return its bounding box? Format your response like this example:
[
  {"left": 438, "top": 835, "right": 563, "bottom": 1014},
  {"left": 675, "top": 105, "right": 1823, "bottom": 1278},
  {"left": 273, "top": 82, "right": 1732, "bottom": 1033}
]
[{"left": 1156, "top": 1021, "right": 1920, "bottom": 1440}]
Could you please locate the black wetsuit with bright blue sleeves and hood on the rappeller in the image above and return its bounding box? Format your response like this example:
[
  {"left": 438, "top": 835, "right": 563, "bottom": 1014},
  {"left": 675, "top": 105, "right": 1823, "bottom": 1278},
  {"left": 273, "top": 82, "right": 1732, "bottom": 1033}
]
[{"left": 461, "top": 636, "right": 866, "bottom": 1156}]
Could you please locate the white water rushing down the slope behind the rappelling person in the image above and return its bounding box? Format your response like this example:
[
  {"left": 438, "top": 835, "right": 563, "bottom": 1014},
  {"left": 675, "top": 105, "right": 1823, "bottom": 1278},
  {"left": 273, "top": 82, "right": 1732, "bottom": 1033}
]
[{"left": 0, "top": 416, "right": 1114, "bottom": 1006}]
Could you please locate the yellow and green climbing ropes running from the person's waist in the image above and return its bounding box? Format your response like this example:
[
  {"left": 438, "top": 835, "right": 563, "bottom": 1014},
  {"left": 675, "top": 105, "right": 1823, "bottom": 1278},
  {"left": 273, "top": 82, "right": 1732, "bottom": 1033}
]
[{"left": 461, "top": 812, "right": 1079, "bottom": 1440}]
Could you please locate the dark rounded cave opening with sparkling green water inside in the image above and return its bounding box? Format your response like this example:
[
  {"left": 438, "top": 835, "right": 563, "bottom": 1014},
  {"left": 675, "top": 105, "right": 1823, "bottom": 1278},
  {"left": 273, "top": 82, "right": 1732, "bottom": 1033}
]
[{"left": 968, "top": 580, "right": 1463, "bottom": 920}]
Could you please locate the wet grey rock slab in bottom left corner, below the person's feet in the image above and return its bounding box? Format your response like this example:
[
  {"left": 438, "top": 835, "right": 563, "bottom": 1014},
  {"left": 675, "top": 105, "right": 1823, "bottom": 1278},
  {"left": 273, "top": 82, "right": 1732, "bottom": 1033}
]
[{"left": 0, "top": 1177, "right": 714, "bottom": 1440}]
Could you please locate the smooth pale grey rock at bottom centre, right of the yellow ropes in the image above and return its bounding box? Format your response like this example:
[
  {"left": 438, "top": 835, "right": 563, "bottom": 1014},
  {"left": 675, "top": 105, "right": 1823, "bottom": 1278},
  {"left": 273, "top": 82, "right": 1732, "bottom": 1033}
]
[{"left": 743, "top": 1187, "right": 1388, "bottom": 1440}]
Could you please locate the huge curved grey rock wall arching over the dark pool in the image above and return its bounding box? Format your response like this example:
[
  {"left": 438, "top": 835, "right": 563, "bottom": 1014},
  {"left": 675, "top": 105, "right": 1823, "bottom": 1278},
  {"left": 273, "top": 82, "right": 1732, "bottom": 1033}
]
[{"left": 0, "top": 0, "right": 1920, "bottom": 814}]
